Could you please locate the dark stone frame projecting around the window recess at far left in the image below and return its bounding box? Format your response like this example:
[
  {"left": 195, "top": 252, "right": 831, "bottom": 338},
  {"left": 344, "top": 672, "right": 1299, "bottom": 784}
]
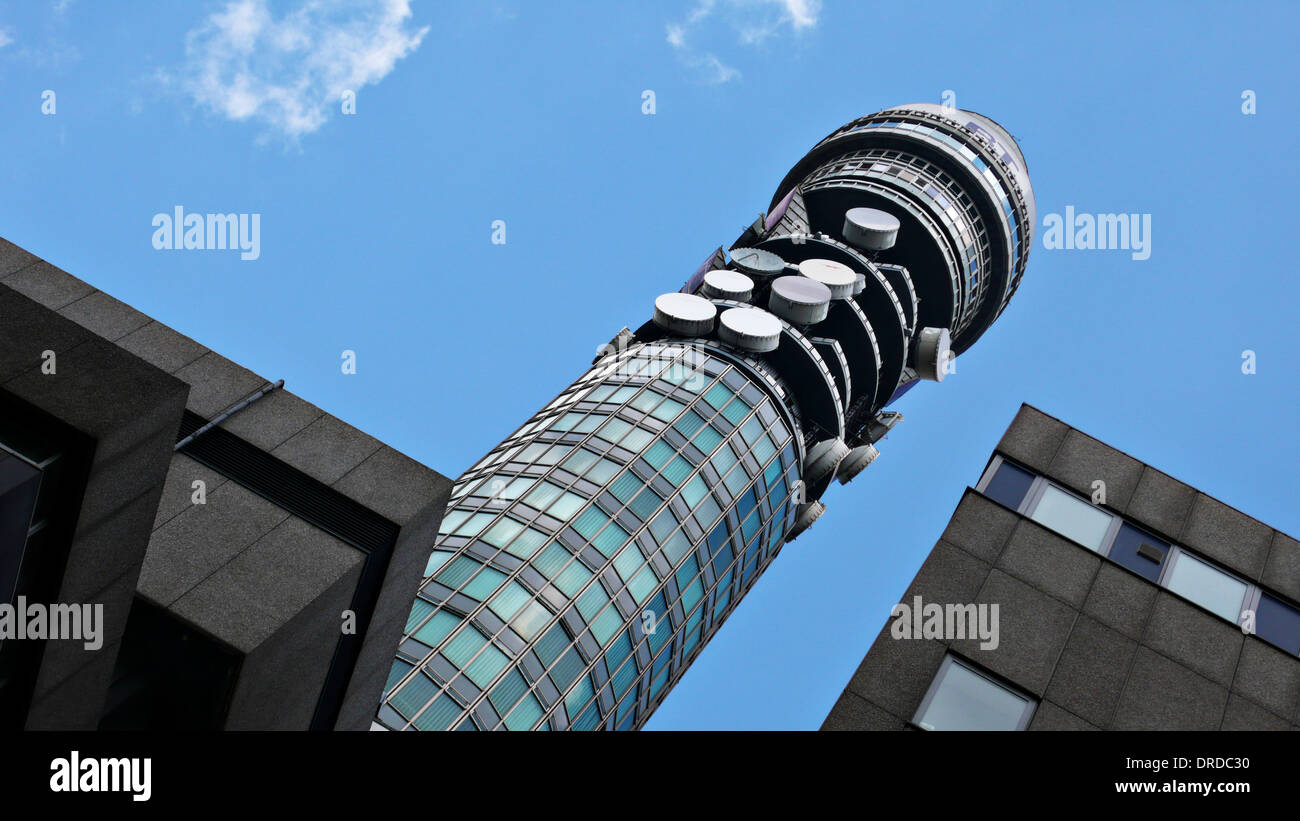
[{"left": 0, "top": 277, "right": 189, "bottom": 729}]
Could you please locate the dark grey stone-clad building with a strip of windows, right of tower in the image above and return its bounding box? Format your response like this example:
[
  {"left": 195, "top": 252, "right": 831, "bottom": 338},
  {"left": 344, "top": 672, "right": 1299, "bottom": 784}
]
[{"left": 822, "top": 405, "right": 1300, "bottom": 730}]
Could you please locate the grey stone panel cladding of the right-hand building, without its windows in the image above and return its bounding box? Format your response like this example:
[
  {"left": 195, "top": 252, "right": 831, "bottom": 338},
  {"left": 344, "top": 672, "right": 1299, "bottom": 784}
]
[{"left": 823, "top": 405, "right": 1300, "bottom": 730}]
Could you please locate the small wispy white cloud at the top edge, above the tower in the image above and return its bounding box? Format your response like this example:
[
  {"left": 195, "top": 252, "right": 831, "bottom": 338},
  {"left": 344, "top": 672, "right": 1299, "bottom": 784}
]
[{"left": 667, "top": 0, "right": 822, "bottom": 83}]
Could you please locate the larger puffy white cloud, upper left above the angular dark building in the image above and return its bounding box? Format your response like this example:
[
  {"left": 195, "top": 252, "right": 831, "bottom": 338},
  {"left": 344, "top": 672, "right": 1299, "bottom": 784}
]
[{"left": 175, "top": 0, "right": 429, "bottom": 139}]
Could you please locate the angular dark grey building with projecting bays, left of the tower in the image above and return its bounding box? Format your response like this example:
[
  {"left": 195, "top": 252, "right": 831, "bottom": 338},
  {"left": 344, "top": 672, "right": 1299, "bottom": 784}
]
[{"left": 0, "top": 240, "right": 450, "bottom": 730}]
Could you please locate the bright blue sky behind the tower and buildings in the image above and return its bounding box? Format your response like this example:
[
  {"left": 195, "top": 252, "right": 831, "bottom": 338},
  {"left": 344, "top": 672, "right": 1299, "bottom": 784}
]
[{"left": 0, "top": 0, "right": 1300, "bottom": 729}]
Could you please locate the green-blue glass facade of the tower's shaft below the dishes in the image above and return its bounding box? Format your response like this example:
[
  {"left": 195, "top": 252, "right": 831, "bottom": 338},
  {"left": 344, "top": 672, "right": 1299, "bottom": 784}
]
[{"left": 378, "top": 343, "right": 800, "bottom": 730}]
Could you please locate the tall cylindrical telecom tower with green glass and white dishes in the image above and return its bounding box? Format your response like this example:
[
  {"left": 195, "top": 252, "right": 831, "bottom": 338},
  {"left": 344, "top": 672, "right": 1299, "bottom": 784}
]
[{"left": 377, "top": 104, "right": 1035, "bottom": 730}]
